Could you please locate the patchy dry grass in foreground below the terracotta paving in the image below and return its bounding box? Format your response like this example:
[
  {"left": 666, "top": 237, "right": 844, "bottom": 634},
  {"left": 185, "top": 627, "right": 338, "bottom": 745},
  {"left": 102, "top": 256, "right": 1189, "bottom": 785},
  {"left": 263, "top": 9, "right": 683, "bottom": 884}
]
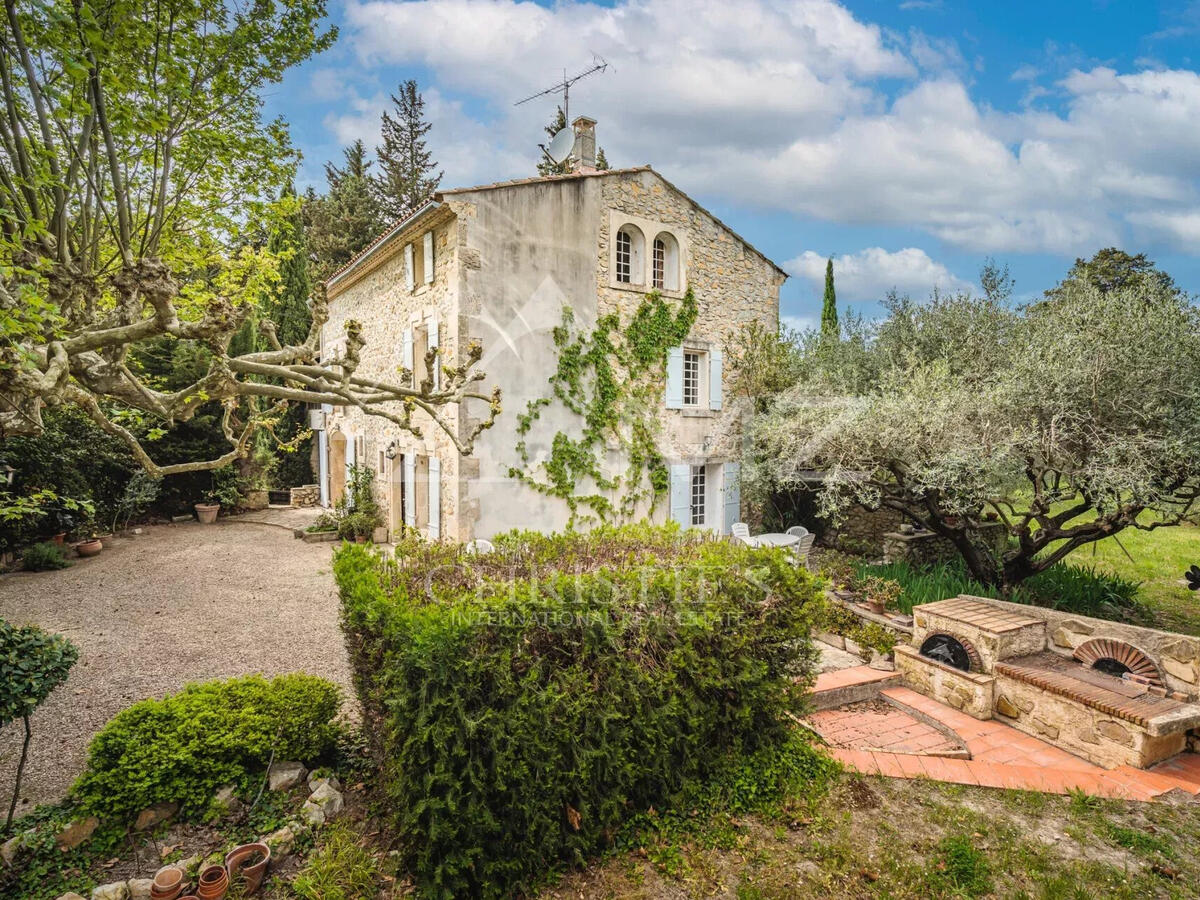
[{"left": 540, "top": 774, "right": 1200, "bottom": 900}]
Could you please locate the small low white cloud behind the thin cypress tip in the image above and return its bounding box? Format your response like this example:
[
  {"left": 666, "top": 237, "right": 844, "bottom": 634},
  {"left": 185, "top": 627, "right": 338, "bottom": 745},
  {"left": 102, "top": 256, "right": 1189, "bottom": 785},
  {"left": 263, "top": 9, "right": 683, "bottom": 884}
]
[{"left": 784, "top": 247, "right": 972, "bottom": 302}]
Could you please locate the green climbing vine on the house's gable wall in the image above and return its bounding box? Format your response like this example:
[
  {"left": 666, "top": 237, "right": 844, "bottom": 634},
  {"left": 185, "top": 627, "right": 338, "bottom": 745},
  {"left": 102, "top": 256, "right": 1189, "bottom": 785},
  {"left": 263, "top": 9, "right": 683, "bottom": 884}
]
[{"left": 509, "top": 288, "right": 696, "bottom": 528}]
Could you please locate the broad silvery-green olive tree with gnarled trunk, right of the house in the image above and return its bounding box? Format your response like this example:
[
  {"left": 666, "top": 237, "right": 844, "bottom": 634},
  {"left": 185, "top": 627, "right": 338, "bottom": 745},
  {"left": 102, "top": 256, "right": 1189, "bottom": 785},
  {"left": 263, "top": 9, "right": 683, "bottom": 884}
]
[{"left": 746, "top": 282, "right": 1200, "bottom": 592}]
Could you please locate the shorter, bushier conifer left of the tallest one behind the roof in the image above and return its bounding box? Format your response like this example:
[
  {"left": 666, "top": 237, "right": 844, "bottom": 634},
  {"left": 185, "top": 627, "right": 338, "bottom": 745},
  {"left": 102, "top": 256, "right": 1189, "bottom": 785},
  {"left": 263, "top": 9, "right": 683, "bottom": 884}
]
[{"left": 304, "top": 140, "right": 383, "bottom": 281}]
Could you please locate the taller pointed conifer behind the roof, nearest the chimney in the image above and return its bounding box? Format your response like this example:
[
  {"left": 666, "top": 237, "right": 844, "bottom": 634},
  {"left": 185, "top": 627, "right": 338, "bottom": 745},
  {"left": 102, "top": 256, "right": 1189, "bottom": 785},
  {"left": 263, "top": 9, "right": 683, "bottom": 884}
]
[{"left": 374, "top": 78, "right": 444, "bottom": 218}]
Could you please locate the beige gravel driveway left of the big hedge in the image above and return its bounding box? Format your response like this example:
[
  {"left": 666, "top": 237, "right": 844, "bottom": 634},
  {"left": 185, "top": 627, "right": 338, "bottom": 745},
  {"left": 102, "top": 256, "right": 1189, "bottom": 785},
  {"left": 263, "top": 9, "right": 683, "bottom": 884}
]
[{"left": 0, "top": 516, "right": 350, "bottom": 815}]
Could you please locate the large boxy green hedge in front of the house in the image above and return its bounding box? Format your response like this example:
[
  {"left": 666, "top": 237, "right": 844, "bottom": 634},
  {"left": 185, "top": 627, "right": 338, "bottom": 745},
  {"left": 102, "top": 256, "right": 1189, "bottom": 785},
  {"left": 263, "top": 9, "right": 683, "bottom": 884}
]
[{"left": 334, "top": 526, "right": 820, "bottom": 896}]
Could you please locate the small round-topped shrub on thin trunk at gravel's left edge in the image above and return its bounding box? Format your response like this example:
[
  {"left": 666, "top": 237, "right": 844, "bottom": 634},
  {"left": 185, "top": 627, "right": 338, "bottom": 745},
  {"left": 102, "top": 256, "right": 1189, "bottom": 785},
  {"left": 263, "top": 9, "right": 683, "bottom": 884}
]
[{"left": 0, "top": 619, "right": 79, "bottom": 832}]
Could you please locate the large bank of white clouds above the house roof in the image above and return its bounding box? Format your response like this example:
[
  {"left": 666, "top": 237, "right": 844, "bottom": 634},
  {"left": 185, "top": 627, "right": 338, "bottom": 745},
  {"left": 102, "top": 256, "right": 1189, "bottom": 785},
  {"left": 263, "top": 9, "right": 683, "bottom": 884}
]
[{"left": 326, "top": 0, "right": 1200, "bottom": 254}]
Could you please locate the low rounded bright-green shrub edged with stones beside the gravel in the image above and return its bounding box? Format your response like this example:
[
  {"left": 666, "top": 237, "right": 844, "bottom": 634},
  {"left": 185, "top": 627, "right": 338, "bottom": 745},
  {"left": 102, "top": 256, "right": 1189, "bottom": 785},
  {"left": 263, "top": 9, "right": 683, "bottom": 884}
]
[{"left": 74, "top": 674, "right": 341, "bottom": 821}]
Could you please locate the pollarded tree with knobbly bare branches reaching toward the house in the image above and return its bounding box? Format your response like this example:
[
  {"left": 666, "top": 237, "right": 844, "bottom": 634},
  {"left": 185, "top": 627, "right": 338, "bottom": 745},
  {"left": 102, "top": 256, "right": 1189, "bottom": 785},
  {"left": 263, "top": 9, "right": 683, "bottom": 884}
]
[{"left": 0, "top": 0, "right": 499, "bottom": 476}]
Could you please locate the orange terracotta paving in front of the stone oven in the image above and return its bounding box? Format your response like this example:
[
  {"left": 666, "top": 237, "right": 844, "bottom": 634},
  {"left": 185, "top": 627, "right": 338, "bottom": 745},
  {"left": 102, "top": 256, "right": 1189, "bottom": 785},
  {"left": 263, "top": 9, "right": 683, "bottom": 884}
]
[{"left": 812, "top": 666, "right": 1200, "bottom": 800}]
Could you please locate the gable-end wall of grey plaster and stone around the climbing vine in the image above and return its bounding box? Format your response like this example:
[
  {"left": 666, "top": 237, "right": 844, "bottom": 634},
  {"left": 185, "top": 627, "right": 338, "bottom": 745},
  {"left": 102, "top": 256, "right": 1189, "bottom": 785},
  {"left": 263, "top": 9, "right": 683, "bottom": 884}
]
[{"left": 451, "top": 172, "right": 781, "bottom": 538}]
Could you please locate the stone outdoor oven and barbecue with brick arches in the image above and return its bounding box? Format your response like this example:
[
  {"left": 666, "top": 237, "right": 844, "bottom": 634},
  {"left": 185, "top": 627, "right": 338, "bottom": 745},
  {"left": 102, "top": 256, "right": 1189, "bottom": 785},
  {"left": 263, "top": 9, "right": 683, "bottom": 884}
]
[{"left": 895, "top": 596, "right": 1200, "bottom": 768}]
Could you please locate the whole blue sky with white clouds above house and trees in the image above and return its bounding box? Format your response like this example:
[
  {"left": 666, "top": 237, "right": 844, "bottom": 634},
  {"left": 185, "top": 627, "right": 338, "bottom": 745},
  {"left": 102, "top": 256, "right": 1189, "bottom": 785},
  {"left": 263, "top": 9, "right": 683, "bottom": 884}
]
[{"left": 268, "top": 0, "right": 1200, "bottom": 331}]
